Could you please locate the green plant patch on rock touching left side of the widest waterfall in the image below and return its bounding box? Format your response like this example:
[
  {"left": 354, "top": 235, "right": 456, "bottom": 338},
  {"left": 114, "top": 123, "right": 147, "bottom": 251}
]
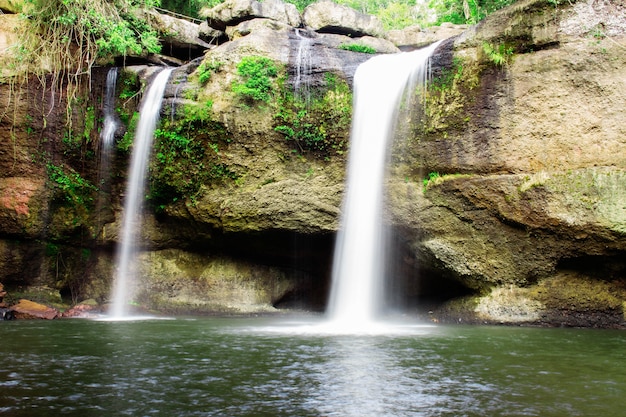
[{"left": 274, "top": 73, "right": 352, "bottom": 157}]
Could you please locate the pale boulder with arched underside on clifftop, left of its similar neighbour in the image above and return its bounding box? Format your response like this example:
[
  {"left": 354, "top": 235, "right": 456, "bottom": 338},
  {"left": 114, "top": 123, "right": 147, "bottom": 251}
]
[{"left": 200, "top": 0, "right": 301, "bottom": 31}]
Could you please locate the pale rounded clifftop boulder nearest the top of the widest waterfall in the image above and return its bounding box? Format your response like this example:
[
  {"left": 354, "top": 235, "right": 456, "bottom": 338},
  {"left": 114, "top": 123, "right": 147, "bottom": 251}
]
[{"left": 302, "top": 0, "right": 385, "bottom": 37}]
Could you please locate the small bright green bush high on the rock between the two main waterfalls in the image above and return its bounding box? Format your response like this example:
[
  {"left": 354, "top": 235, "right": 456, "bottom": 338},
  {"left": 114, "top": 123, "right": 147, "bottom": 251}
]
[{"left": 232, "top": 55, "right": 278, "bottom": 103}]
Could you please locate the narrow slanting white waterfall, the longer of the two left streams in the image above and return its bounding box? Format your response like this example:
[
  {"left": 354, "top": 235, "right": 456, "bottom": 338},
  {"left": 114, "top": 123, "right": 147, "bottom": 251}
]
[{"left": 110, "top": 68, "right": 172, "bottom": 318}]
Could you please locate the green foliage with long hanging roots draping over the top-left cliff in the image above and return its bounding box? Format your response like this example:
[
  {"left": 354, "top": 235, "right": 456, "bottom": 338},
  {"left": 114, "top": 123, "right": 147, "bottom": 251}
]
[{"left": 7, "top": 0, "right": 160, "bottom": 120}]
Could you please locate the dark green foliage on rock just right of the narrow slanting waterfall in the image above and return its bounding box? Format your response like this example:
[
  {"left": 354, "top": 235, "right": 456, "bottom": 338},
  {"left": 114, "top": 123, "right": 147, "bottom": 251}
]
[{"left": 149, "top": 101, "right": 238, "bottom": 209}]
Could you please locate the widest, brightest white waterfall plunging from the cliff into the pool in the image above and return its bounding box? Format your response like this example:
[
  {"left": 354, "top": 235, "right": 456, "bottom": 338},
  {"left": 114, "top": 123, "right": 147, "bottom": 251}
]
[{"left": 327, "top": 44, "right": 438, "bottom": 329}]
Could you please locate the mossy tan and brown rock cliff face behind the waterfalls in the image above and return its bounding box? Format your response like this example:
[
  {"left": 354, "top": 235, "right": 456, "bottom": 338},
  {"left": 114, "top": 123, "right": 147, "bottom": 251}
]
[{"left": 0, "top": 0, "right": 626, "bottom": 327}]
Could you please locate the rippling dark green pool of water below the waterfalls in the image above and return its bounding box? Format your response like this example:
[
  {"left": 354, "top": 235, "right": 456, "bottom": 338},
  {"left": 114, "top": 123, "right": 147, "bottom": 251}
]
[{"left": 0, "top": 318, "right": 626, "bottom": 417}]
